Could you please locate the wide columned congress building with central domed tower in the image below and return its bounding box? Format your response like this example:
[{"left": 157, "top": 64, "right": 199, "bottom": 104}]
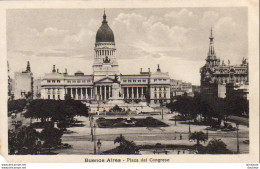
[{"left": 41, "top": 13, "right": 177, "bottom": 104}]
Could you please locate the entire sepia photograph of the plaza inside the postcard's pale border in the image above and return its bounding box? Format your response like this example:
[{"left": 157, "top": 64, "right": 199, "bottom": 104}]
[{"left": 5, "top": 7, "right": 254, "bottom": 159}]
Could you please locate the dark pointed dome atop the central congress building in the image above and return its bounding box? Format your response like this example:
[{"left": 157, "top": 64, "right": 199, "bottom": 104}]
[{"left": 96, "top": 13, "right": 115, "bottom": 43}]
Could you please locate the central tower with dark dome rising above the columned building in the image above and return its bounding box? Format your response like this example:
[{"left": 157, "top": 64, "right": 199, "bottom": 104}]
[{"left": 93, "top": 11, "right": 119, "bottom": 81}]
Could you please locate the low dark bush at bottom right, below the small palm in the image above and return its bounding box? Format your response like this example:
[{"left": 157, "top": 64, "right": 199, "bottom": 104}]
[{"left": 205, "top": 139, "right": 232, "bottom": 154}]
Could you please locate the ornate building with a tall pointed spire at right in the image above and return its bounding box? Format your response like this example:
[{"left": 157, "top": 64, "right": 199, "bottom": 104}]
[{"left": 200, "top": 29, "right": 248, "bottom": 98}]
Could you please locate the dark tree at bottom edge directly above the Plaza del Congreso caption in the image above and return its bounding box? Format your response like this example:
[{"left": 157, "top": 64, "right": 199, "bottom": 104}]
[{"left": 113, "top": 134, "right": 139, "bottom": 154}]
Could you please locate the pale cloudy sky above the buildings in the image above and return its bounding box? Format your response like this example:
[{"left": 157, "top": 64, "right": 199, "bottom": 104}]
[{"left": 7, "top": 7, "right": 248, "bottom": 85}]
